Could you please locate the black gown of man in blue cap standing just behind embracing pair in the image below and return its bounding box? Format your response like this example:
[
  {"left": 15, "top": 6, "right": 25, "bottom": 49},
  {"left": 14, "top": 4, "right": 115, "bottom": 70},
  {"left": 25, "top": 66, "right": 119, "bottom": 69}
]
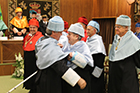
[{"left": 90, "top": 53, "right": 105, "bottom": 93}]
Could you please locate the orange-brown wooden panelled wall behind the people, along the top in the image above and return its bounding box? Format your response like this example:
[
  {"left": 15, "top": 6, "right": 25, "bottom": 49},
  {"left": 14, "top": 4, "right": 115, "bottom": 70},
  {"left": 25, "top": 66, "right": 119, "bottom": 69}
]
[{"left": 0, "top": 0, "right": 135, "bottom": 33}]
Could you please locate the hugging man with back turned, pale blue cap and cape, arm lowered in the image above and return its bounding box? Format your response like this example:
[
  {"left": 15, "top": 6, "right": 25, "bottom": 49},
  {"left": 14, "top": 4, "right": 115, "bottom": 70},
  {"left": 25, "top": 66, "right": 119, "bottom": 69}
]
[{"left": 36, "top": 16, "right": 86, "bottom": 93}]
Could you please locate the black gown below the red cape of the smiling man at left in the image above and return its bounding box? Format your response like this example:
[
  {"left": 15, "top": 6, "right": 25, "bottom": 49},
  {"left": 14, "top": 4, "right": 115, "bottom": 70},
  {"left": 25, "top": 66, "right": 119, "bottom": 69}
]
[{"left": 23, "top": 50, "right": 38, "bottom": 93}]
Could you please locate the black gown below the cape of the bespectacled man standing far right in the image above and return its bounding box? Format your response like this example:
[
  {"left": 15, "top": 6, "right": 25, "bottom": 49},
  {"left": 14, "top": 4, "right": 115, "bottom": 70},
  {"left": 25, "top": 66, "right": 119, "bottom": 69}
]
[{"left": 108, "top": 50, "right": 140, "bottom": 93}]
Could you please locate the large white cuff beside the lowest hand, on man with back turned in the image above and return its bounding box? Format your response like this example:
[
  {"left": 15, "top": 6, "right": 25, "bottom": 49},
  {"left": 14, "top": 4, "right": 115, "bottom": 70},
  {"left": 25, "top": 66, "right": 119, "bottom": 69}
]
[{"left": 62, "top": 68, "right": 81, "bottom": 86}]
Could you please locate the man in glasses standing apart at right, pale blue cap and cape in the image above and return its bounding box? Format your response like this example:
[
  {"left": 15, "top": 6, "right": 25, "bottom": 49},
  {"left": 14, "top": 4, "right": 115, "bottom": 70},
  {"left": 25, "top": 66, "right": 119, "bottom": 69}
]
[{"left": 108, "top": 15, "right": 140, "bottom": 93}]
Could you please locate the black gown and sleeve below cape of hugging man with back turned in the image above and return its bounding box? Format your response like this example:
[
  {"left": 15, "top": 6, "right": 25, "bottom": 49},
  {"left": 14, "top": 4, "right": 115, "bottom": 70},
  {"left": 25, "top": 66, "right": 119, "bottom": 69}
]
[{"left": 35, "top": 58, "right": 68, "bottom": 93}]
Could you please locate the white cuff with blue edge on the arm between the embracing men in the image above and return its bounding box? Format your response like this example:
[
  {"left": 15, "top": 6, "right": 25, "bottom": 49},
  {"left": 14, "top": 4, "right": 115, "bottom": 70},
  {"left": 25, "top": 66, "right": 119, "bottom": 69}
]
[{"left": 71, "top": 51, "right": 87, "bottom": 68}]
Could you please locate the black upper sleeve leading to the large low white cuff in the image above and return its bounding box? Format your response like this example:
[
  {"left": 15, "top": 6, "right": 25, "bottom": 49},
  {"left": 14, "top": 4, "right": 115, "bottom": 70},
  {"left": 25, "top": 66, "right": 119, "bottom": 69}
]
[{"left": 51, "top": 58, "right": 69, "bottom": 76}]
